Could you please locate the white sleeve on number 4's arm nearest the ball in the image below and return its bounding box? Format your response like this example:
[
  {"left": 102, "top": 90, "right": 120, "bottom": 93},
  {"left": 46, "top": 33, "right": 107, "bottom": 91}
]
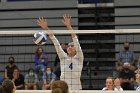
[{"left": 50, "top": 36, "right": 66, "bottom": 59}]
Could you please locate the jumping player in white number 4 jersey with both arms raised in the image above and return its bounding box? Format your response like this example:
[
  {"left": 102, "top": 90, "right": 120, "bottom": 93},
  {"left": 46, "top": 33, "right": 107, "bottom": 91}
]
[{"left": 37, "top": 15, "right": 84, "bottom": 90}]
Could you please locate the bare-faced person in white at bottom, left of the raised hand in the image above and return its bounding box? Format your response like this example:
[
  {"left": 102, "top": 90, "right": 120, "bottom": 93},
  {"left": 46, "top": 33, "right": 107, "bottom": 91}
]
[{"left": 102, "top": 77, "right": 114, "bottom": 90}]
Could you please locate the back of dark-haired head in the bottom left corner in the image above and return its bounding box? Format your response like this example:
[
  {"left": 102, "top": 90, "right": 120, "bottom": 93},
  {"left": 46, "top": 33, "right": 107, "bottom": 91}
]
[{"left": 0, "top": 79, "right": 16, "bottom": 93}]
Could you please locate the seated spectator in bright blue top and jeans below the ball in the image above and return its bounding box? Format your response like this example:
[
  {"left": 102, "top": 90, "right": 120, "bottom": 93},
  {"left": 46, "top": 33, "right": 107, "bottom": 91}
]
[{"left": 35, "top": 47, "right": 48, "bottom": 81}]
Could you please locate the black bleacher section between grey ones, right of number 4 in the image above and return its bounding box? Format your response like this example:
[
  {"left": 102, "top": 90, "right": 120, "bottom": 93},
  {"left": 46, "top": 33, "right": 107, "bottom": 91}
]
[{"left": 78, "top": 0, "right": 115, "bottom": 89}]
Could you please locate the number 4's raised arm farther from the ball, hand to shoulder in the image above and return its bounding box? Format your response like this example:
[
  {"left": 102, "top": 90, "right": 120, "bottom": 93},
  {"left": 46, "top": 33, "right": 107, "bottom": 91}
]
[{"left": 62, "top": 15, "right": 83, "bottom": 61}]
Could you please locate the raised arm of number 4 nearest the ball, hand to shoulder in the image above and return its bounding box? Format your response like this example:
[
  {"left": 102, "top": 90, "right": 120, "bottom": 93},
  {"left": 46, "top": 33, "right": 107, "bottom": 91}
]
[{"left": 37, "top": 17, "right": 65, "bottom": 58}]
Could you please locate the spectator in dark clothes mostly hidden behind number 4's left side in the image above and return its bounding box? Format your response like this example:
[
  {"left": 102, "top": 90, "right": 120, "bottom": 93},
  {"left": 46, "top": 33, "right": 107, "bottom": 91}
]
[{"left": 54, "top": 43, "right": 67, "bottom": 80}]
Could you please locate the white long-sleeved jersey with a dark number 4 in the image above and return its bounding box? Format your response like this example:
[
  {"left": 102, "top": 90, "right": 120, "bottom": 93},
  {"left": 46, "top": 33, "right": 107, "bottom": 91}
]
[{"left": 50, "top": 36, "right": 84, "bottom": 90}]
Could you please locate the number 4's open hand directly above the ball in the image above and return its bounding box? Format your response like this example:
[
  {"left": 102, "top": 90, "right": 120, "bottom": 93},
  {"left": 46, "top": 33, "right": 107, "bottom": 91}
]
[{"left": 37, "top": 17, "right": 48, "bottom": 30}]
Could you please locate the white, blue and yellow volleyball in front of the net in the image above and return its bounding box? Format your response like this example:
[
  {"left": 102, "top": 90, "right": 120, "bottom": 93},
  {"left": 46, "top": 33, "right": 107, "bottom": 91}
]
[{"left": 33, "top": 31, "right": 47, "bottom": 45}]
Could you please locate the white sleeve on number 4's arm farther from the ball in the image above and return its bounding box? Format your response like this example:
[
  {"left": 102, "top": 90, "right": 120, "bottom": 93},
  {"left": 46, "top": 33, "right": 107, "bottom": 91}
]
[{"left": 73, "top": 36, "right": 84, "bottom": 62}]
